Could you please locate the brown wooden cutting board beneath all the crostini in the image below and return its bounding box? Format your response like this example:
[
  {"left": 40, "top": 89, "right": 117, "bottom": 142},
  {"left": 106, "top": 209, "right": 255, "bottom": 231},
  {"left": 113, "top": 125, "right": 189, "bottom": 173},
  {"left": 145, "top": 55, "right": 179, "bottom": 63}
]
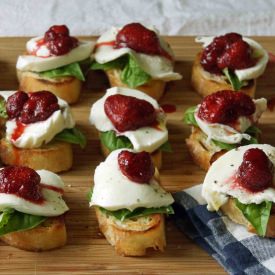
[{"left": 0, "top": 37, "right": 275, "bottom": 274}]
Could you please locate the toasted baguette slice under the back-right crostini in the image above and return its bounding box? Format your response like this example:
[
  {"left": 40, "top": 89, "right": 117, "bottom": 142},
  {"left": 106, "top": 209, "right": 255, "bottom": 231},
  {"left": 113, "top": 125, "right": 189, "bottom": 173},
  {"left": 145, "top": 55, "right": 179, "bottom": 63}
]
[{"left": 191, "top": 53, "right": 256, "bottom": 97}]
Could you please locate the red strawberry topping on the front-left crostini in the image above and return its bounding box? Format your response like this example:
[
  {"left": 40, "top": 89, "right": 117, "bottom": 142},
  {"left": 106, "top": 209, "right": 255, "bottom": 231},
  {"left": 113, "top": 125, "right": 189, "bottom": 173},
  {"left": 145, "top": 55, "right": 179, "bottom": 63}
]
[{"left": 0, "top": 166, "right": 43, "bottom": 203}]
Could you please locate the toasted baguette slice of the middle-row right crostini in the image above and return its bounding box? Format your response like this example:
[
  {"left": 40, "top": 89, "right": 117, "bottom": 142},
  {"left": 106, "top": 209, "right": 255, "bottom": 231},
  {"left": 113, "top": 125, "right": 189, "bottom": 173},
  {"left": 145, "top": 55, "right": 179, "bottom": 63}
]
[{"left": 186, "top": 127, "right": 226, "bottom": 171}]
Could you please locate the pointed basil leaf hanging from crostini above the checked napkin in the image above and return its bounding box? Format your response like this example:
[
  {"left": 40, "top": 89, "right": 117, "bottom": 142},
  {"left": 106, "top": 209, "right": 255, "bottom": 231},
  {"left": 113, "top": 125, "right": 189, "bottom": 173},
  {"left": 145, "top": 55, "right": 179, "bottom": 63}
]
[{"left": 235, "top": 199, "right": 272, "bottom": 237}]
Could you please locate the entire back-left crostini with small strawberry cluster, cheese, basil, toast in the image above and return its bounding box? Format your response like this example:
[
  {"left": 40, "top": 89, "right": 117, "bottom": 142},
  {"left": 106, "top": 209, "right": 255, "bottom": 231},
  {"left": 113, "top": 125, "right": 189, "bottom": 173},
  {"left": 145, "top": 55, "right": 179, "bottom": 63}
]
[{"left": 16, "top": 25, "right": 94, "bottom": 103}]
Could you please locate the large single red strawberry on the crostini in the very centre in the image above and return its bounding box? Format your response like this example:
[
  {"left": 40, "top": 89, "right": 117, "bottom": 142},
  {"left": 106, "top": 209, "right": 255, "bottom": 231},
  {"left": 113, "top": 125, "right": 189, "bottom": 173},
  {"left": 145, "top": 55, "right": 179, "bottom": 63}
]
[{"left": 104, "top": 95, "right": 156, "bottom": 132}]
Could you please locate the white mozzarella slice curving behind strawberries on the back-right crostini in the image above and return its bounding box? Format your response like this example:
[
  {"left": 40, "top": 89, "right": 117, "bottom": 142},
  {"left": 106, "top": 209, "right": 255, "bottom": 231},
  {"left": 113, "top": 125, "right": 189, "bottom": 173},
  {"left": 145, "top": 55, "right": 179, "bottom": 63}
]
[{"left": 195, "top": 36, "right": 269, "bottom": 81}]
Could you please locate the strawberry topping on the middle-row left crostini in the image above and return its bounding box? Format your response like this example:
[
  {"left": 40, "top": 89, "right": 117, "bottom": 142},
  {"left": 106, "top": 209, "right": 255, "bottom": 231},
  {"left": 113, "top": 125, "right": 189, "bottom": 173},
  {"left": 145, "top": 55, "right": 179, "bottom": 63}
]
[{"left": 6, "top": 91, "right": 60, "bottom": 124}]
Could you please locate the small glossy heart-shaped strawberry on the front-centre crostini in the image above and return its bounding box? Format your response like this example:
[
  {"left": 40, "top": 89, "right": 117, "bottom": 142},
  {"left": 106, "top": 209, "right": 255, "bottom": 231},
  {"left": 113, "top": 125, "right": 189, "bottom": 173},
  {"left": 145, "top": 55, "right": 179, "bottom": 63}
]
[{"left": 118, "top": 150, "right": 155, "bottom": 183}]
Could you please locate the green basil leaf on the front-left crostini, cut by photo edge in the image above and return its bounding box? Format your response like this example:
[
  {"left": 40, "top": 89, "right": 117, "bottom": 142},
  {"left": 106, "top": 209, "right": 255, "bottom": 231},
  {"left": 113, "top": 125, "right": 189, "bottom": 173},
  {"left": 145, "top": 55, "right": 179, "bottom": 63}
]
[{"left": 0, "top": 209, "right": 47, "bottom": 236}]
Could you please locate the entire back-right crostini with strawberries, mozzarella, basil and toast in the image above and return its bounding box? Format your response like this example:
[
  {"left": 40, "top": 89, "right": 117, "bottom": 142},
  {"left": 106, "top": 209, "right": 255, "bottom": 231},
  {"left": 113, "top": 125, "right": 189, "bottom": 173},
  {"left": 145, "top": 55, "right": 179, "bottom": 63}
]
[{"left": 191, "top": 33, "right": 268, "bottom": 97}]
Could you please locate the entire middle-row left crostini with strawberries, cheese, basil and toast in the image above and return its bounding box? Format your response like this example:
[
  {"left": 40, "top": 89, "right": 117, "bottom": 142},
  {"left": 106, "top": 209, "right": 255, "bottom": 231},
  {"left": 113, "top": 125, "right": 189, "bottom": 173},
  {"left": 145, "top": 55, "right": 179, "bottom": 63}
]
[{"left": 0, "top": 91, "right": 85, "bottom": 172}]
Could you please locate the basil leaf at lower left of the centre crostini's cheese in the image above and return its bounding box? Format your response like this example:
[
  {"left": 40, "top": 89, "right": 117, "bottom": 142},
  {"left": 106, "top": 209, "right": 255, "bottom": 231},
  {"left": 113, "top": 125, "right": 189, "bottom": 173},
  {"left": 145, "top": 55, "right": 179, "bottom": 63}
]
[{"left": 100, "top": 131, "right": 133, "bottom": 152}]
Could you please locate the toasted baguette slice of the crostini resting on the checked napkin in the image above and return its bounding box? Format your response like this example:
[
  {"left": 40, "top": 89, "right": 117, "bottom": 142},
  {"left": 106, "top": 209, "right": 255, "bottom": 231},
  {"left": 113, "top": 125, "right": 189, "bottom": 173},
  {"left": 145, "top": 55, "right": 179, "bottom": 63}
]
[{"left": 221, "top": 198, "right": 275, "bottom": 238}]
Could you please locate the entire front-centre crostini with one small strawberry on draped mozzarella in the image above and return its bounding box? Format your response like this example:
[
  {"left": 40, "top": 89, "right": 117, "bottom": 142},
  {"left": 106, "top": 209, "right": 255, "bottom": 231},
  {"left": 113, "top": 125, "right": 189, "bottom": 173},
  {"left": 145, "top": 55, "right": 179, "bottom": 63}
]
[{"left": 90, "top": 149, "right": 174, "bottom": 256}]
